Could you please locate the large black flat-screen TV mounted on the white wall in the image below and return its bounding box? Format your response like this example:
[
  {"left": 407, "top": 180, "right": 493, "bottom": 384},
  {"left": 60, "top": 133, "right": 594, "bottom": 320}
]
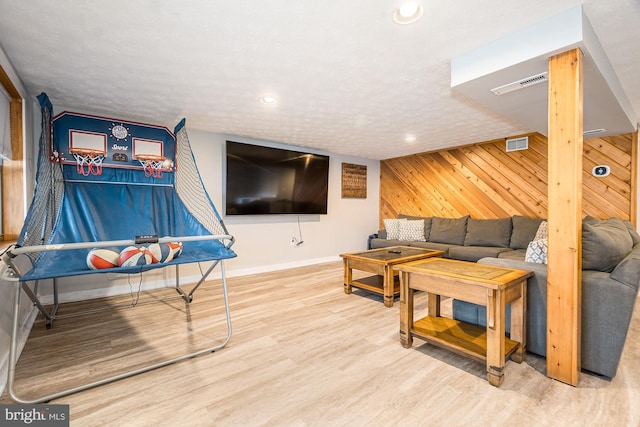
[{"left": 225, "top": 141, "right": 329, "bottom": 215}]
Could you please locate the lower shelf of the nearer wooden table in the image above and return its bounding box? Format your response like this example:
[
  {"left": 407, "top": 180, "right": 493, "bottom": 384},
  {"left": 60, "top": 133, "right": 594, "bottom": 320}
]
[{"left": 411, "top": 316, "right": 520, "bottom": 362}]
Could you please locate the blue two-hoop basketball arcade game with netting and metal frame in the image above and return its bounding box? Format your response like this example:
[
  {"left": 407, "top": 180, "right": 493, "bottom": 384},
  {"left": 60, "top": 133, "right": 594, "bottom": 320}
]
[{"left": 1, "top": 94, "right": 236, "bottom": 403}]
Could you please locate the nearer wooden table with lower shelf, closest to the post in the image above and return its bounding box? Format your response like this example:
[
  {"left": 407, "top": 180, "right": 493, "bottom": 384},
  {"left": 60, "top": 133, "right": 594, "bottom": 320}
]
[{"left": 396, "top": 258, "right": 533, "bottom": 386}]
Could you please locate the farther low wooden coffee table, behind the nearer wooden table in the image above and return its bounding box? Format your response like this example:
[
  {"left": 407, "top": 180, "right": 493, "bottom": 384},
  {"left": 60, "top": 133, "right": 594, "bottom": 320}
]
[{"left": 340, "top": 246, "right": 444, "bottom": 307}]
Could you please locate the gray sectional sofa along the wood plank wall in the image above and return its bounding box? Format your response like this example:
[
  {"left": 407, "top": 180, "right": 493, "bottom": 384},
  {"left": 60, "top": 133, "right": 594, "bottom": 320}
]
[{"left": 370, "top": 215, "right": 640, "bottom": 378}]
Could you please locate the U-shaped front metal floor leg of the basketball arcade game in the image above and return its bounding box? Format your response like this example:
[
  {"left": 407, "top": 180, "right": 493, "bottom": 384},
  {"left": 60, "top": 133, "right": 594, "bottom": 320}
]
[{"left": 7, "top": 262, "right": 232, "bottom": 404}]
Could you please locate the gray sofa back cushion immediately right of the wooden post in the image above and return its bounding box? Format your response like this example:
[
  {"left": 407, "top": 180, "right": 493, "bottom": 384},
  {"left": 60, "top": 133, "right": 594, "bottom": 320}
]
[{"left": 582, "top": 218, "right": 633, "bottom": 272}]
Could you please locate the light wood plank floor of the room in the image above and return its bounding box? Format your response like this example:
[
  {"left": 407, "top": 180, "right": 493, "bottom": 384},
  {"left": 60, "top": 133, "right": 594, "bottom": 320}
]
[{"left": 1, "top": 262, "right": 640, "bottom": 427}]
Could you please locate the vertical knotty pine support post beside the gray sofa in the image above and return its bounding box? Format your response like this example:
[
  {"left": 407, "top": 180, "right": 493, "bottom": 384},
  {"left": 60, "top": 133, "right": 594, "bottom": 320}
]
[{"left": 547, "top": 49, "right": 583, "bottom": 386}]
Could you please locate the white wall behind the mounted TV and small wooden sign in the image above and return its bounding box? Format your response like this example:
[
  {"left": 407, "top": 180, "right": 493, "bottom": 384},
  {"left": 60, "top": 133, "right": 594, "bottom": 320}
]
[{"left": 187, "top": 130, "right": 380, "bottom": 274}]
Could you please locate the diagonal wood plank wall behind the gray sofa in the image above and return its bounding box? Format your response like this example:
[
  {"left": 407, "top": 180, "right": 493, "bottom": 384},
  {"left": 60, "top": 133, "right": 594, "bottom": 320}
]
[{"left": 379, "top": 133, "right": 637, "bottom": 228}]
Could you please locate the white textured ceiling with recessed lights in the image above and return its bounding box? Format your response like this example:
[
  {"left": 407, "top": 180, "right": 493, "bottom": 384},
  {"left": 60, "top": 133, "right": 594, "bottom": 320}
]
[{"left": 0, "top": 0, "right": 640, "bottom": 159}]
